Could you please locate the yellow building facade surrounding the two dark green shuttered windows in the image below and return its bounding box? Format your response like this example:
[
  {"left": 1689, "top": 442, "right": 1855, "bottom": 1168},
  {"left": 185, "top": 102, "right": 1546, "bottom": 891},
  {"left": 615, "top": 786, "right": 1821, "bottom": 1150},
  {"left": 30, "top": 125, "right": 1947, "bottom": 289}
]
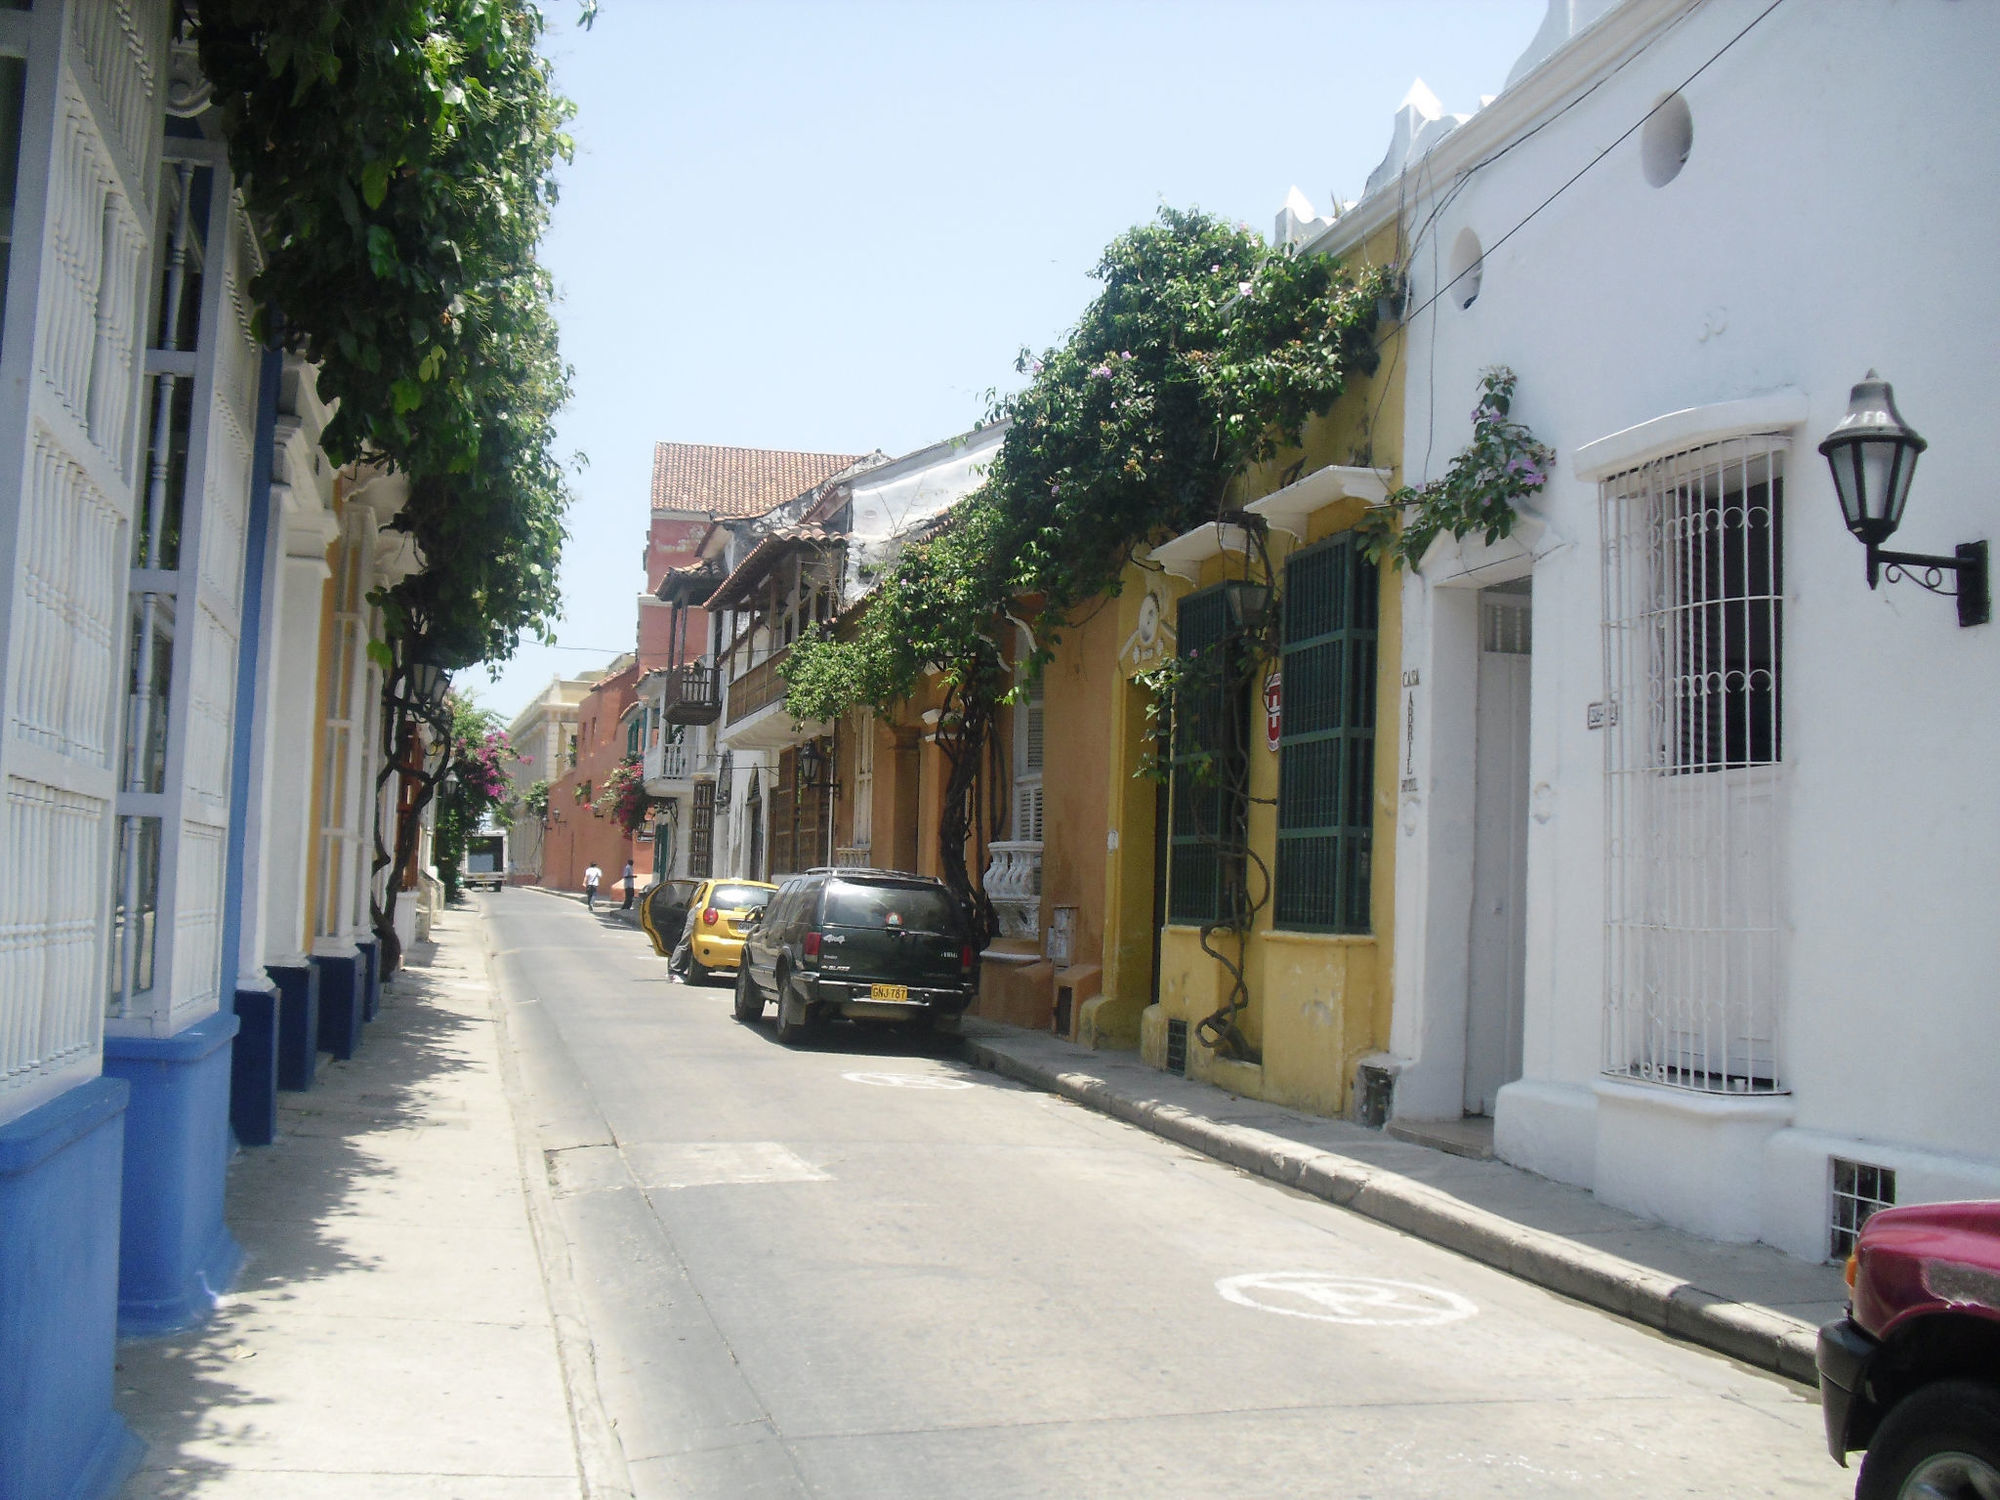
[{"left": 1096, "top": 220, "right": 1402, "bottom": 1114}]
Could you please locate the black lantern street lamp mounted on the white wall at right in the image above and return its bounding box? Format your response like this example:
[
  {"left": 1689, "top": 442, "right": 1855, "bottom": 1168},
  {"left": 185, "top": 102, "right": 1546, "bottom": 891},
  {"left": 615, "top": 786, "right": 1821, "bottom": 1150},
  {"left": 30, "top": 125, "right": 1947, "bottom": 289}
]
[{"left": 1820, "top": 370, "right": 1992, "bottom": 626}]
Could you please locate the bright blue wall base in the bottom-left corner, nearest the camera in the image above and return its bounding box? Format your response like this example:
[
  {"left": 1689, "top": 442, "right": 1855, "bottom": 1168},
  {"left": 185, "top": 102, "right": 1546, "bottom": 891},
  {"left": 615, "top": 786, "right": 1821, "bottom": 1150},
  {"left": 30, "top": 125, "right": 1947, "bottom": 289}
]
[{"left": 0, "top": 1078, "right": 146, "bottom": 1500}]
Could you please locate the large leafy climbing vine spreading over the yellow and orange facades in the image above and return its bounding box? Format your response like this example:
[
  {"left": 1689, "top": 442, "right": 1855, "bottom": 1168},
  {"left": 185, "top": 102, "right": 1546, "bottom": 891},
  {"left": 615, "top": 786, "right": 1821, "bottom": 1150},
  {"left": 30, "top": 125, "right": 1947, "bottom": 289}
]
[{"left": 784, "top": 210, "right": 1394, "bottom": 720}]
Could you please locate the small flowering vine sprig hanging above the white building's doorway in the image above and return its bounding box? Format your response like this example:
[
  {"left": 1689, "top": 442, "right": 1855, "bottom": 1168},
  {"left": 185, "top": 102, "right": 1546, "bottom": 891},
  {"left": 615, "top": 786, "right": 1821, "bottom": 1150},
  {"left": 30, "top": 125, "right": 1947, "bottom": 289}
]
[{"left": 1356, "top": 364, "right": 1556, "bottom": 568}]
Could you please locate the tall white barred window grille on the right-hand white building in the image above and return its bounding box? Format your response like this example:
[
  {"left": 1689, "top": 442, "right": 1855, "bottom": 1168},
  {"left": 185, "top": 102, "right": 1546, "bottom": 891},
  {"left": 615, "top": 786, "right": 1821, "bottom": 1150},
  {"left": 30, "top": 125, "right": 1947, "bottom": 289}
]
[{"left": 1600, "top": 436, "right": 1784, "bottom": 1094}]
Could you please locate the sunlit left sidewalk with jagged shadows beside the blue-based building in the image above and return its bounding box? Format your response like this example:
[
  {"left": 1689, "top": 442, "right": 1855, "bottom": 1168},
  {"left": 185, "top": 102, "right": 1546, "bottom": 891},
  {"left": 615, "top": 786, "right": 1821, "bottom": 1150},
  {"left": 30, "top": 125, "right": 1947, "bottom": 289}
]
[{"left": 116, "top": 912, "right": 618, "bottom": 1500}]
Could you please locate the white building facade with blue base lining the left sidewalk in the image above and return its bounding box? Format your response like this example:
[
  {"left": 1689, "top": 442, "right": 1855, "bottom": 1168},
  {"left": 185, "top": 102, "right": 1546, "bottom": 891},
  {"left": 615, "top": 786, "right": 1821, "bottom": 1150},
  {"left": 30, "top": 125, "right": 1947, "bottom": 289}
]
[{"left": 0, "top": 0, "right": 436, "bottom": 1500}]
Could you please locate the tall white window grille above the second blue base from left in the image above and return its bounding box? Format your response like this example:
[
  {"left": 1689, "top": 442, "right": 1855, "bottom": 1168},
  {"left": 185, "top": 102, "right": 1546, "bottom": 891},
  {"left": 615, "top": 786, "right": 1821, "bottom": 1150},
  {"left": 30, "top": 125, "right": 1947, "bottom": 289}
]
[{"left": 107, "top": 138, "right": 262, "bottom": 1032}]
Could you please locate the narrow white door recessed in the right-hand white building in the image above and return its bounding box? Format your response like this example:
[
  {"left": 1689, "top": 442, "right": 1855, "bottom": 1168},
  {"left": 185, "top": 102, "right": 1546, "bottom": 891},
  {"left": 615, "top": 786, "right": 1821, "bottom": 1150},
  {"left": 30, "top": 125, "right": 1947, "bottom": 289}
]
[{"left": 1464, "top": 578, "right": 1534, "bottom": 1116}]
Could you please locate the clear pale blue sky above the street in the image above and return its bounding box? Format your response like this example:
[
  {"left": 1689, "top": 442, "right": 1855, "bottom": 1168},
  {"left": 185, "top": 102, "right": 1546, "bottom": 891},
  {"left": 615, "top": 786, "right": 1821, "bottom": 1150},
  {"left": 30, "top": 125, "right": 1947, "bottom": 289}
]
[{"left": 480, "top": 0, "right": 1546, "bottom": 716}]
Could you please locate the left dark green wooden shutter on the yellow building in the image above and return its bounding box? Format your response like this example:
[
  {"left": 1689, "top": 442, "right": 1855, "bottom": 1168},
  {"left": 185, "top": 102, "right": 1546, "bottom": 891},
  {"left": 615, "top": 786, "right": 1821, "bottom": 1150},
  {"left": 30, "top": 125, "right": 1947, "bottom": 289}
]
[{"left": 1166, "top": 588, "right": 1242, "bottom": 924}]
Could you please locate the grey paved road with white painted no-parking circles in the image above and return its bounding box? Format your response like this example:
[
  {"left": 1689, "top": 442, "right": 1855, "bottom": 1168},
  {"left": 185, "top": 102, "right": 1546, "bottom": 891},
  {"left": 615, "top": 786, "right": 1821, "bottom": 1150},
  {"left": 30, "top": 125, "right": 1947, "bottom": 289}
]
[{"left": 484, "top": 890, "right": 1852, "bottom": 1500}]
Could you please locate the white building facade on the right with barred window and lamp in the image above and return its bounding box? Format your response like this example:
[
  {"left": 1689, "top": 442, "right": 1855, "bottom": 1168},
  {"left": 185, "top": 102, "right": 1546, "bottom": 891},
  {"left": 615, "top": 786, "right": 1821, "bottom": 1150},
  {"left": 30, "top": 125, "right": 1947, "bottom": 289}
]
[{"left": 1344, "top": 0, "right": 2000, "bottom": 1260}]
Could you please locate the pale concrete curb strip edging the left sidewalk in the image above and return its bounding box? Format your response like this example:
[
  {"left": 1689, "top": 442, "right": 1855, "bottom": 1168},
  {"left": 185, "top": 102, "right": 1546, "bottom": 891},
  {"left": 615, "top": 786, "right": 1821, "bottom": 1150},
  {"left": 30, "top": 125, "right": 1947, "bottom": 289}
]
[{"left": 478, "top": 918, "right": 634, "bottom": 1500}]
